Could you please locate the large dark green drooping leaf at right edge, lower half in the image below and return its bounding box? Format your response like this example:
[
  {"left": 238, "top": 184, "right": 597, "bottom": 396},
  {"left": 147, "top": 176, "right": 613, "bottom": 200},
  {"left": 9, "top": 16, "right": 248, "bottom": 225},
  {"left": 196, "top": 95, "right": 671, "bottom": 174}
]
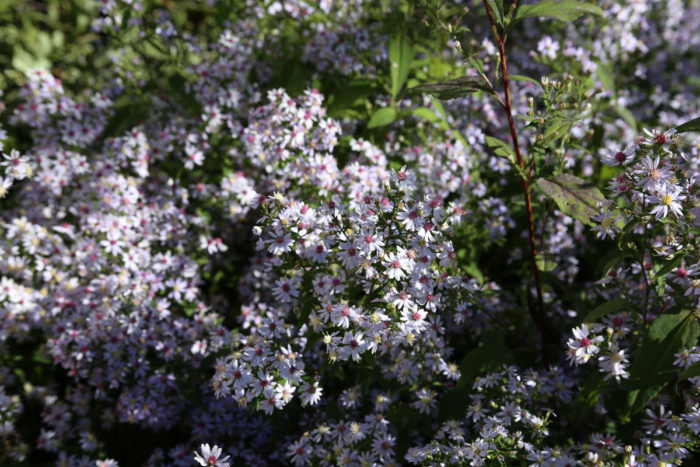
[{"left": 627, "top": 310, "right": 700, "bottom": 414}]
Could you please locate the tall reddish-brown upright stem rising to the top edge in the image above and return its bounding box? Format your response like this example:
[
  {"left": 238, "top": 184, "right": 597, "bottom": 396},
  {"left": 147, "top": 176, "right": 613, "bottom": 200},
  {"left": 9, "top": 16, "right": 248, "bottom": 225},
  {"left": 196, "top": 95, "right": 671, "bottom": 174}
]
[{"left": 484, "top": 0, "right": 547, "bottom": 362}]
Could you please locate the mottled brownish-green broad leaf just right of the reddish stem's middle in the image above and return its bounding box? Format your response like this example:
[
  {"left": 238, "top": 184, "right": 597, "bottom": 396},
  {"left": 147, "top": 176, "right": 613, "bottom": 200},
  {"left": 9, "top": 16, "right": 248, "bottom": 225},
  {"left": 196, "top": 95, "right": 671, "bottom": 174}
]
[{"left": 535, "top": 173, "right": 609, "bottom": 225}]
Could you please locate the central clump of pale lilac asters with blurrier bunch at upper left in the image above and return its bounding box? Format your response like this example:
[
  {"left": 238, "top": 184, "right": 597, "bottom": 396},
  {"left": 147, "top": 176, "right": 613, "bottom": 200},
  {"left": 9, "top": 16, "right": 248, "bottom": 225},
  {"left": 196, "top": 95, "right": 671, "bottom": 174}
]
[{"left": 214, "top": 91, "right": 476, "bottom": 412}]
